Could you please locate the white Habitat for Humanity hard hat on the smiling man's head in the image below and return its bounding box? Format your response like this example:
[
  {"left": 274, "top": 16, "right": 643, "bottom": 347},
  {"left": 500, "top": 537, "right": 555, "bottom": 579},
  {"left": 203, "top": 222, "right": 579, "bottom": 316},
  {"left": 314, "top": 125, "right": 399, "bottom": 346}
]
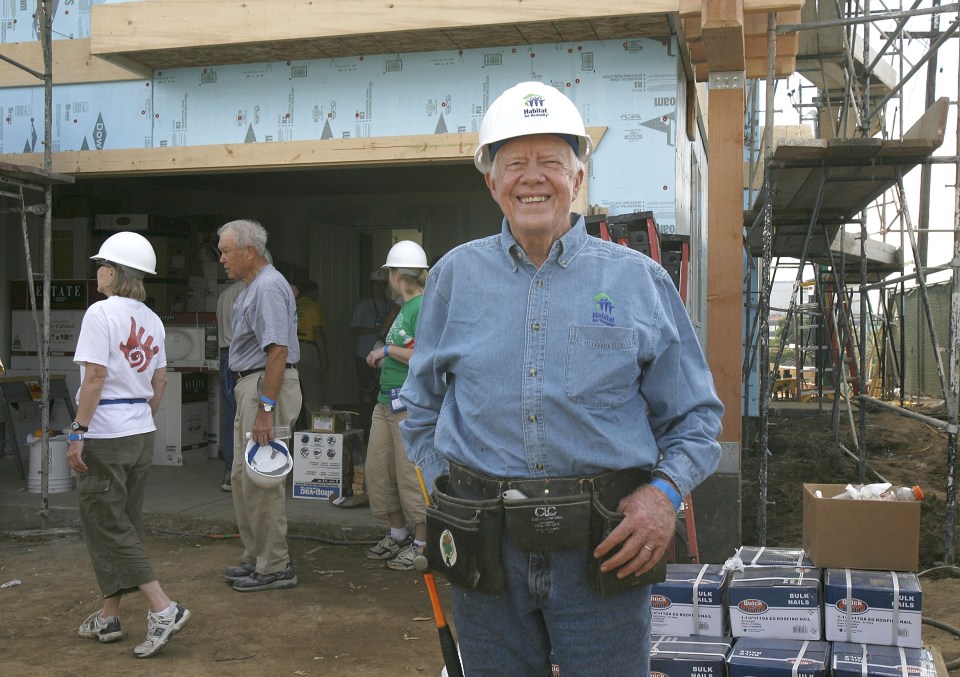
[{"left": 473, "top": 82, "right": 593, "bottom": 173}]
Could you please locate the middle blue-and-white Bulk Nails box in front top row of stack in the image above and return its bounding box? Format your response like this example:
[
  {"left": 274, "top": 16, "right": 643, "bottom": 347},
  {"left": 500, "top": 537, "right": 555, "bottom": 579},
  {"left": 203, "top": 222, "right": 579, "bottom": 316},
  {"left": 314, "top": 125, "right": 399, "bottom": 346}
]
[{"left": 727, "top": 567, "right": 823, "bottom": 640}]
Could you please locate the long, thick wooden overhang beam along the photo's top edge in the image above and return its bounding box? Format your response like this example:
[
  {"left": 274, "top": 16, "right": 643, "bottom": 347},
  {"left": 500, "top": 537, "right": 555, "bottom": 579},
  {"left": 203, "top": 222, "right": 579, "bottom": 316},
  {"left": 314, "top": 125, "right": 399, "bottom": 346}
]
[{"left": 91, "top": 0, "right": 679, "bottom": 55}]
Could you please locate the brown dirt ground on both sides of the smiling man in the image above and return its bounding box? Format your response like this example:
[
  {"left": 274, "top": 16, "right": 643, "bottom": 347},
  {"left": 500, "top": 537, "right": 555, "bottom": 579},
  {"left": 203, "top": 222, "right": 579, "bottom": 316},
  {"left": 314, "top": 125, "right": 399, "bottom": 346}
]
[{"left": 0, "top": 404, "right": 960, "bottom": 677}]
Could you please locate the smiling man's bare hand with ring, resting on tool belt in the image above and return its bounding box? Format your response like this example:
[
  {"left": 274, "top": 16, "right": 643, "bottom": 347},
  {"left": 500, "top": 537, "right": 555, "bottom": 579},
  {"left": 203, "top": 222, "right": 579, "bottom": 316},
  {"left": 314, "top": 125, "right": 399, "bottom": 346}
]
[{"left": 593, "top": 485, "right": 677, "bottom": 578}]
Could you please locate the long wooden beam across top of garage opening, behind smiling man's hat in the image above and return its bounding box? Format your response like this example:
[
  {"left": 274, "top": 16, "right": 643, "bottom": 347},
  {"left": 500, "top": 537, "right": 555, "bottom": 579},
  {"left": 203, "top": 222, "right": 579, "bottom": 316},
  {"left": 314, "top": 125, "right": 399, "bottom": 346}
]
[{"left": 4, "top": 127, "right": 607, "bottom": 176}]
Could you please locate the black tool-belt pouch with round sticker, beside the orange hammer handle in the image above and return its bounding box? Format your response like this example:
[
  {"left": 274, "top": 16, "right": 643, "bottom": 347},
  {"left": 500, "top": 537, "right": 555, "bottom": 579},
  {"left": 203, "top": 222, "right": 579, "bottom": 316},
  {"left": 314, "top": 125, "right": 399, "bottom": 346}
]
[{"left": 426, "top": 475, "right": 503, "bottom": 595}]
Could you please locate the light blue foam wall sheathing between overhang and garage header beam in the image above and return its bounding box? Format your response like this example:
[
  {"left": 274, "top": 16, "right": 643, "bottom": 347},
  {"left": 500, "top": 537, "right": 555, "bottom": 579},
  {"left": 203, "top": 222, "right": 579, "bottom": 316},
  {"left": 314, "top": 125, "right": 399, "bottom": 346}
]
[{"left": 0, "top": 37, "right": 686, "bottom": 232}]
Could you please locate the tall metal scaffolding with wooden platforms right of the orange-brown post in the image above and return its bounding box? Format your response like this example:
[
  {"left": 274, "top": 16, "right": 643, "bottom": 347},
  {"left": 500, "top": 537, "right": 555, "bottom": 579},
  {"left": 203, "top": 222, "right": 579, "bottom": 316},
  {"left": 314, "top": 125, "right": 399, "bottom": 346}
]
[{"left": 744, "top": 0, "right": 960, "bottom": 563}]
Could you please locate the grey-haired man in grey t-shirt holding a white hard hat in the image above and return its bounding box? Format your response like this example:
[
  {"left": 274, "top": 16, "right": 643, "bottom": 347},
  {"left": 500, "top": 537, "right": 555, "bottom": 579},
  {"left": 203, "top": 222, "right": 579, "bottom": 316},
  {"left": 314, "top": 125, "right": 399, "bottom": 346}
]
[{"left": 217, "top": 220, "right": 303, "bottom": 592}]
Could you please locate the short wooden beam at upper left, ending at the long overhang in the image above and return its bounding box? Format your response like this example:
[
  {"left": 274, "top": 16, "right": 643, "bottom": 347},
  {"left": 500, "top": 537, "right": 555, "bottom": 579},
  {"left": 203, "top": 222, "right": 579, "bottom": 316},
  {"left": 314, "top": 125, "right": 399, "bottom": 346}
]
[{"left": 0, "top": 38, "right": 152, "bottom": 88}]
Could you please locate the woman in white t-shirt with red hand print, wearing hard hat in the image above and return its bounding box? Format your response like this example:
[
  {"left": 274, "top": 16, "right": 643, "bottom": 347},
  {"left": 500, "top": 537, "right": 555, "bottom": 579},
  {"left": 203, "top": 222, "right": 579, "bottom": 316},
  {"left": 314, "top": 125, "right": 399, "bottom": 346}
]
[{"left": 67, "top": 232, "right": 190, "bottom": 658}]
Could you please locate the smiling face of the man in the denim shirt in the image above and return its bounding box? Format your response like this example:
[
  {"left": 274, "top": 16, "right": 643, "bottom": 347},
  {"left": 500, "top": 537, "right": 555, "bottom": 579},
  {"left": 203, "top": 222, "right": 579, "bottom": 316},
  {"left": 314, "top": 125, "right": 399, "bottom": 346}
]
[{"left": 485, "top": 134, "right": 583, "bottom": 244}]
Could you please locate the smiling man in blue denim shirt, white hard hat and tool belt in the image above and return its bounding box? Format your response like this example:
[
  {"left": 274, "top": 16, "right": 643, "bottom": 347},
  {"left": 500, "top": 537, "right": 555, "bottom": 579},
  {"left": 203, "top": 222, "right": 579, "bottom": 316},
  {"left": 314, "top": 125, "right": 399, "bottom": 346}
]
[{"left": 401, "top": 82, "right": 722, "bottom": 676}]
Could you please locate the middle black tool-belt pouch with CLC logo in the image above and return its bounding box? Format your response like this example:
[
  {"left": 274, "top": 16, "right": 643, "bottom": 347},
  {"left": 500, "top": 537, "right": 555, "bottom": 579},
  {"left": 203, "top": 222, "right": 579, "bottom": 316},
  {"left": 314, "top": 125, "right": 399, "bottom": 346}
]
[{"left": 503, "top": 493, "right": 590, "bottom": 552}]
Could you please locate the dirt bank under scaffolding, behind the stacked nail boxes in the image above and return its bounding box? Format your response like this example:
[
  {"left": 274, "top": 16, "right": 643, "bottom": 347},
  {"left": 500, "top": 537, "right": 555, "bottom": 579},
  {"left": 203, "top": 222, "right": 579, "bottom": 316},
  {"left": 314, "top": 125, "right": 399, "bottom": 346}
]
[{"left": 742, "top": 404, "right": 960, "bottom": 675}]
